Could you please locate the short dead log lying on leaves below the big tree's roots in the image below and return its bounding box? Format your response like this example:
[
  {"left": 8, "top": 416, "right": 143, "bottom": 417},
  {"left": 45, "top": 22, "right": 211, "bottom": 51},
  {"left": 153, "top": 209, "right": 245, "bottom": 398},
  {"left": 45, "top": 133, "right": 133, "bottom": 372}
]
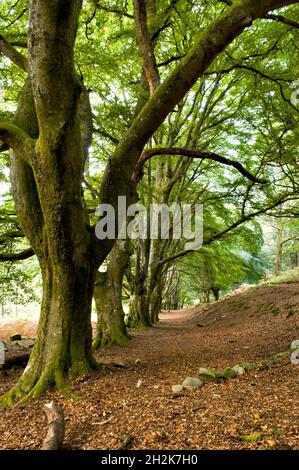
[{"left": 41, "top": 401, "right": 65, "bottom": 450}]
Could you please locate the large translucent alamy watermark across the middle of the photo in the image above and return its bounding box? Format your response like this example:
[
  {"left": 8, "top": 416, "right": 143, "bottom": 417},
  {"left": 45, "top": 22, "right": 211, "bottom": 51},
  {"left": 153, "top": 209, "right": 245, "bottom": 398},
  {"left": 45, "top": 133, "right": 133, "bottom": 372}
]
[{"left": 95, "top": 196, "right": 203, "bottom": 250}]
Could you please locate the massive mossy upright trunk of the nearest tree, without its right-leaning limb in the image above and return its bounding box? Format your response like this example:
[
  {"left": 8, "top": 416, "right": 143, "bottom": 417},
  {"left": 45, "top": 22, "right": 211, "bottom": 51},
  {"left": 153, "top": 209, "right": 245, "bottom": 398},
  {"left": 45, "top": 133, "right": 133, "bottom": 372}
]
[{"left": 3, "top": 0, "right": 99, "bottom": 404}]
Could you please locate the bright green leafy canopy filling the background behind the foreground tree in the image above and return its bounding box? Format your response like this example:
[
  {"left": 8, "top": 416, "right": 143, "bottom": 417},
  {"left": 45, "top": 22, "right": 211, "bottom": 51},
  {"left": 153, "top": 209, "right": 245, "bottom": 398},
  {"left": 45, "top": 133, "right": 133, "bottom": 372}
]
[{"left": 0, "top": 0, "right": 299, "bottom": 312}]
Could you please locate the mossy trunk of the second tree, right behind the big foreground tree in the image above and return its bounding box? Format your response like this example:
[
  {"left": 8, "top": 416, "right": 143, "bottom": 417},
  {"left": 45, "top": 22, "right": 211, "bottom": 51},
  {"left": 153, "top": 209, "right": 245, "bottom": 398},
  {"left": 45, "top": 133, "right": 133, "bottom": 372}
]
[{"left": 93, "top": 240, "right": 130, "bottom": 349}]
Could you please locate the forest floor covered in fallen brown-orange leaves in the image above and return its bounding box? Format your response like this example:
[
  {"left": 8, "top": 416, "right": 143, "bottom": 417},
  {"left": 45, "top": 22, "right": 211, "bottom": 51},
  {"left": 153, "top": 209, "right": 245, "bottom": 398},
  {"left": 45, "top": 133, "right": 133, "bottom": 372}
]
[{"left": 0, "top": 271, "right": 299, "bottom": 450}]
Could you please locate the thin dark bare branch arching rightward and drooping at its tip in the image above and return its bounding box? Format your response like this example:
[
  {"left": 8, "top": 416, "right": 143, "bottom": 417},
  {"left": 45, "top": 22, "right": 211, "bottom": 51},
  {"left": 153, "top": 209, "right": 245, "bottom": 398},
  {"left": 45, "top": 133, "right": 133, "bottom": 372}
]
[{"left": 133, "top": 147, "right": 266, "bottom": 184}]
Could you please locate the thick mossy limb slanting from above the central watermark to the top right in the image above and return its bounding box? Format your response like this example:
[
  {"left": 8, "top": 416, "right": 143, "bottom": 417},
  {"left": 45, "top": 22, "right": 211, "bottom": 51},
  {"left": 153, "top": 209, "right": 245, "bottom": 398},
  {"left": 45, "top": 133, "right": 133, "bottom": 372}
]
[{"left": 101, "top": 0, "right": 299, "bottom": 199}]
